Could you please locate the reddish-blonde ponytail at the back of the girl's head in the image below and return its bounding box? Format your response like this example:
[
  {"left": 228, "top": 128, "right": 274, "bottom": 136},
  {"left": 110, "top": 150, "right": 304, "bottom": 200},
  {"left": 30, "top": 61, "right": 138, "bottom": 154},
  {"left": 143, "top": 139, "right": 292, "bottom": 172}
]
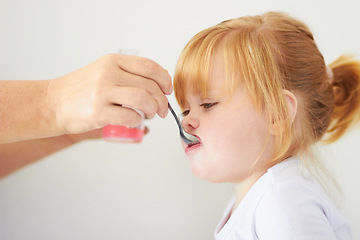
[{"left": 323, "top": 56, "right": 360, "bottom": 144}]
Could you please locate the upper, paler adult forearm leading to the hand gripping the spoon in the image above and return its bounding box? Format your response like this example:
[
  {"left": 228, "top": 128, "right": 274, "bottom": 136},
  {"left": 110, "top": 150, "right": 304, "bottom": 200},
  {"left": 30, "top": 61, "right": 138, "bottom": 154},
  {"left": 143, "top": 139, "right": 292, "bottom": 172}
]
[{"left": 0, "top": 80, "right": 62, "bottom": 144}]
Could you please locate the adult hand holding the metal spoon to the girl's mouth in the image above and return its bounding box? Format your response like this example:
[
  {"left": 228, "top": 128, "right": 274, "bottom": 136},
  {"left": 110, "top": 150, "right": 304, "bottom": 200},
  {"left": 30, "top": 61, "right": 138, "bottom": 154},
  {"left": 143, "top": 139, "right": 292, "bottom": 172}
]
[{"left": 47, "top": 54, "right": 172, "bottom": 134}]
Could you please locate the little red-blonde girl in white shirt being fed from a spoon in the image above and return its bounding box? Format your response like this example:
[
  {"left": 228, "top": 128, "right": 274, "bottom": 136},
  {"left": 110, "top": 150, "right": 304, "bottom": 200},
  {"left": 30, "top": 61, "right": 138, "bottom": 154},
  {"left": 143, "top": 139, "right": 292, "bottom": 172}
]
[{"left": 174, "top": 12, "right": 360, "bottom": 240}]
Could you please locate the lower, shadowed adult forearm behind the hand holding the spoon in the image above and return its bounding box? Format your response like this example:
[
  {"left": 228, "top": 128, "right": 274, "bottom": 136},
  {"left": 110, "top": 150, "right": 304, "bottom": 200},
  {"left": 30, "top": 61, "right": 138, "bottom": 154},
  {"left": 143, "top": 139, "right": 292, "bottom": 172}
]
[{"left": 0, "top": 135, "right": 75, "bottom": 178}]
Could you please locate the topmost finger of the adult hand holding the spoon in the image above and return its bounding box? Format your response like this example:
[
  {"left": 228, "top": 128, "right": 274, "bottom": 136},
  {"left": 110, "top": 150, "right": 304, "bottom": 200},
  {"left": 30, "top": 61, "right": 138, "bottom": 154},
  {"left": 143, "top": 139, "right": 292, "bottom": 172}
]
[{"left": 117, "top": 54, "right": 173, "bottom": 94}]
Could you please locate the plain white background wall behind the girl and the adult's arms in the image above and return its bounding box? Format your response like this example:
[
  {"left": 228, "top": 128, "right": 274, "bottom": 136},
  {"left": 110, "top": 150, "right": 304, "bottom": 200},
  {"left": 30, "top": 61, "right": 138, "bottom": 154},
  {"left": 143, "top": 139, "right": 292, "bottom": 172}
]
[{"left": 0, "top": 0, "right": 360, "bottom": 240}]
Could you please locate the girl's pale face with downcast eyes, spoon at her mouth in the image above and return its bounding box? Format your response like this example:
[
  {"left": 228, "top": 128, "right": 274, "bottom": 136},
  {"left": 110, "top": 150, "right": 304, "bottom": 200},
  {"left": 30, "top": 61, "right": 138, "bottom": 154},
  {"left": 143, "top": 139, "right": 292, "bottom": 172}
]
[{"left": 182, "top": 58, "right": 272, "bottom": 183}]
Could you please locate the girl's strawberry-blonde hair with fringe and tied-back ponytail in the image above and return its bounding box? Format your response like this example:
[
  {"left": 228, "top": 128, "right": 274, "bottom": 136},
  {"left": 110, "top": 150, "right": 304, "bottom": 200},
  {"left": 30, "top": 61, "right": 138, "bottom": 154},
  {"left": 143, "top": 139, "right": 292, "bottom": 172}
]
[{"left": 174, "top": 12, "right": 360, "bottom": 172}]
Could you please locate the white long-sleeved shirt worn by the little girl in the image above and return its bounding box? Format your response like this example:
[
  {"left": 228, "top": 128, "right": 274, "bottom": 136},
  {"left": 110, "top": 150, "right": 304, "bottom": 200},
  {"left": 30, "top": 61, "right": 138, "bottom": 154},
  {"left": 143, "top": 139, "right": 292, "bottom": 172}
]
[{"left": 214, "top": 158, "right": 352, "bottom": 240}]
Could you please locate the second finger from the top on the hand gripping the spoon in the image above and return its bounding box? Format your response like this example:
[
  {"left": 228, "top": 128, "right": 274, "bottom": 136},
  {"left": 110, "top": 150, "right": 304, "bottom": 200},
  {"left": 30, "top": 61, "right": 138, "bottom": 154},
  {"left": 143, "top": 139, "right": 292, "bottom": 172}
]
[{"left": 111, "top": 72, "right": 168, "bottom": 117}]
